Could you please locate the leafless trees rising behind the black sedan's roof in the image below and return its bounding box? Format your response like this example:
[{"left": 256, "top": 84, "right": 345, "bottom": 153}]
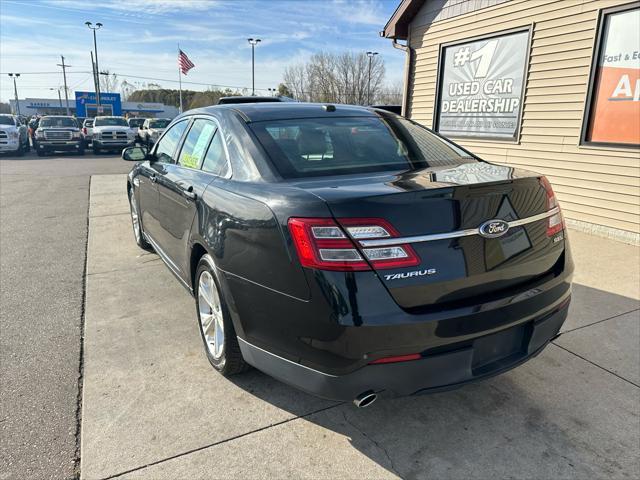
[{"left": 283, "top": 52, "right": 385, "bottom": 105}]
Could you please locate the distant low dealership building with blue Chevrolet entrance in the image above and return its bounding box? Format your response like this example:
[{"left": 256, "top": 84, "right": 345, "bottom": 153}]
[{"left": 10, "top": 92, "right": 178, "bottom": 118}]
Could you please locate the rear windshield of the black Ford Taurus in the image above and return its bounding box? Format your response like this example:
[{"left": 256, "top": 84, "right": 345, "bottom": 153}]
[{"left": 249, "top": 116, "right": 476, "bottom": 178}]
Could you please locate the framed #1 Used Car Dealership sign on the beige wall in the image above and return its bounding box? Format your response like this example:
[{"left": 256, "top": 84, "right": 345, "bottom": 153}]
[{"left": 435, "top": 30, "right": 529, "bottom": 139}]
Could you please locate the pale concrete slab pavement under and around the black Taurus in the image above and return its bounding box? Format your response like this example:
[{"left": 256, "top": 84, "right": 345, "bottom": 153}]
[{"left": 81, "top": 175, "right": 640, "bottom": 479}]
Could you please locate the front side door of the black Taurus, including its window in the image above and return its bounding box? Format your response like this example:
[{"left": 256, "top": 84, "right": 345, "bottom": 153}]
[{"left": 136, "top": 118, "right": 190, "bottom": 251}]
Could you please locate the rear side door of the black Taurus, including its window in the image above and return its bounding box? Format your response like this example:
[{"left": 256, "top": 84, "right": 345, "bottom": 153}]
[{"left": 152, "top": 117, "right": 218, "bottom": 279}]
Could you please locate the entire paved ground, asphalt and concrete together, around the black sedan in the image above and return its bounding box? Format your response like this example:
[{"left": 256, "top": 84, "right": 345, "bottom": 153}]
[{"left": 0, "top": 151, "right": 640, "bottom": 479}]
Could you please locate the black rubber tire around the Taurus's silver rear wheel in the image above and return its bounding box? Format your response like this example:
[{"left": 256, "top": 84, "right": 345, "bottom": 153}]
[{"left": 194, "top": 254, "right": 251, "bottom": 377}]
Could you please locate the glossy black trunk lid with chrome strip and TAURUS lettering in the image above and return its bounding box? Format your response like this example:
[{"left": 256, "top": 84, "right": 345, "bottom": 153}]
[{"left": 296, "top": 162, "right": 564, "bottom": 309}]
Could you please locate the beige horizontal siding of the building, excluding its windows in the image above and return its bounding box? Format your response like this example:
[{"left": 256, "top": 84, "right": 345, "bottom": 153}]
[{"left": 407, "top": 0, "right": 640, "bottom": 234}]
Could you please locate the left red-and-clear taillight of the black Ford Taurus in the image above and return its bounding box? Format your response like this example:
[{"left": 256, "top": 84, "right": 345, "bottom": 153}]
[{"left": 289, "top": 218, "right": 420, "bottom": 271}]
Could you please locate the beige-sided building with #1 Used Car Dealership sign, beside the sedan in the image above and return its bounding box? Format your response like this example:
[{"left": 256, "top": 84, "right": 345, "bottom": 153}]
[{"left": 381, "top": 0, "right": 640, "bottom": 244}]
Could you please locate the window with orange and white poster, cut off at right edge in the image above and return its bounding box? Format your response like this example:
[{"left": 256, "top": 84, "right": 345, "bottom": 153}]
[{"left": 582, "top": 7, "right": 640, "bottom": 146}]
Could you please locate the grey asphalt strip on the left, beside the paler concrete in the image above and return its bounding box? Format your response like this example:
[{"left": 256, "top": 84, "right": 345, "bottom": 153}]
[{"left": 0, "top": 152, "right": 131, "bottom": 479}]
